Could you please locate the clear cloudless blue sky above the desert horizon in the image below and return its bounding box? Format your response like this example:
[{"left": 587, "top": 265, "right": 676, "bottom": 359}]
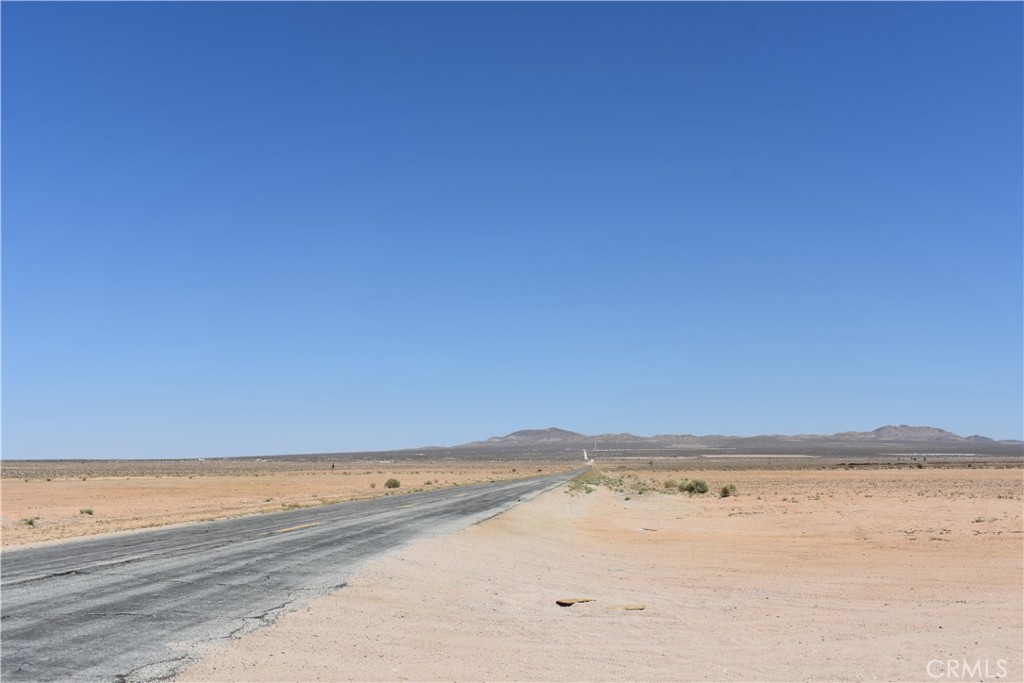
[{"left": 2, "top": 2, "right": 1024, "bottom": 458}]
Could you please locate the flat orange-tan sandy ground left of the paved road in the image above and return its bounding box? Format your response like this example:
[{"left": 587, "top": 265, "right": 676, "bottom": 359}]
[{"left": 0, "top": 461, "right": 577, "bottom": 548}]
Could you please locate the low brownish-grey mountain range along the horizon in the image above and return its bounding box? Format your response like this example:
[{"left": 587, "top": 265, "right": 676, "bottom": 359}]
[{"left": 453, "top": 425, "right": 1024, "bottom": 453}]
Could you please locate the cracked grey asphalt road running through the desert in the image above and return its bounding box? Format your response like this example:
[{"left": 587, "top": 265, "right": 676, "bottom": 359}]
[{"left": 0, "top": 471, "right": 579, "bottom": 683}]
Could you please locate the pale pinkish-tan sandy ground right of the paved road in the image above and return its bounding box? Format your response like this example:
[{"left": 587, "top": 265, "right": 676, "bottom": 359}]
[{"left": 179, "top": 468, "right": 1024, "bottom": 681}]
